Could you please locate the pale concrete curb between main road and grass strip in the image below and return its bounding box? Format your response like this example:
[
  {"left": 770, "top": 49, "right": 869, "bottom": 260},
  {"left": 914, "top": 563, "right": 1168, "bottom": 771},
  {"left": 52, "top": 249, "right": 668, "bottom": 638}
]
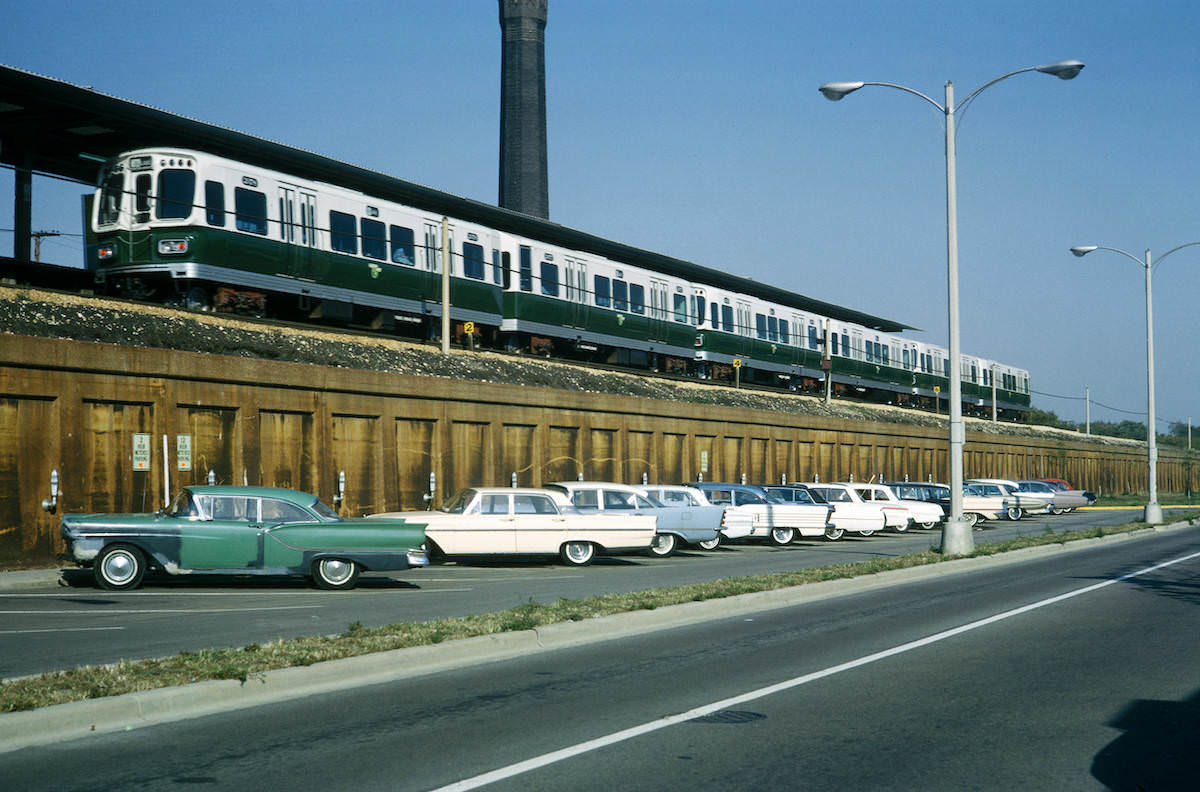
[{"left": 0, "top": 522, "right": 1190, "bottom": 754}]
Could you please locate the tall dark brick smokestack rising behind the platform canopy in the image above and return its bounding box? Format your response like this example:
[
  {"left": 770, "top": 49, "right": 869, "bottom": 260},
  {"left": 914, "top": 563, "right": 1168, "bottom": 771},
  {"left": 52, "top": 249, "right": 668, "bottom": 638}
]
[{"left": 499, "top": 0, "right": 550, "bottom": 218}]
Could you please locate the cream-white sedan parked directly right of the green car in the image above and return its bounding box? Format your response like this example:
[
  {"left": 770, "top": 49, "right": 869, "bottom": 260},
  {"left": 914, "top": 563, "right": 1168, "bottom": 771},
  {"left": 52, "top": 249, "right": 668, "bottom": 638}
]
[{"left": 371, "top": 487, "right": 656, "bottom": 566}]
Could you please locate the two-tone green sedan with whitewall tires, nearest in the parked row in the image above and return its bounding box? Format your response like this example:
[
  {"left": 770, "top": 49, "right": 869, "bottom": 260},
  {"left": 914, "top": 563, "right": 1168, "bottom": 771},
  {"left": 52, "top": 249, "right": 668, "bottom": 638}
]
[{"left": 61, "top": 486, "right": 430, "bottom": 590}]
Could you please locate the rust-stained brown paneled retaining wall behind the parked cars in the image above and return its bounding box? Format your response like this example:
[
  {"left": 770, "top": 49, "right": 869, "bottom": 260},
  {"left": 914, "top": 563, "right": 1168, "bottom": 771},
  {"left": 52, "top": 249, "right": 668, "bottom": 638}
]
[{"left": 0, "top": 334, "right": 1200, "bottom": 566}]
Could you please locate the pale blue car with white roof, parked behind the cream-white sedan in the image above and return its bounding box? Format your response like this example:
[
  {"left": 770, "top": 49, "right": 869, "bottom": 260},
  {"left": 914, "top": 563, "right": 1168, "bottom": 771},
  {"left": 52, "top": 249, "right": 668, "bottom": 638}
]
[{"left": 546, "top": 481, "right": 725, "bottom": 558}]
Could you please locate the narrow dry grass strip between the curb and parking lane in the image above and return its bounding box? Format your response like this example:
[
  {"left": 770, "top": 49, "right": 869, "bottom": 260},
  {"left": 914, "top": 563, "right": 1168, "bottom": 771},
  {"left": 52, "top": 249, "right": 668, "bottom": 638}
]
[{"left": 0, "top": 512, "right": 1200, "bottom": 713}]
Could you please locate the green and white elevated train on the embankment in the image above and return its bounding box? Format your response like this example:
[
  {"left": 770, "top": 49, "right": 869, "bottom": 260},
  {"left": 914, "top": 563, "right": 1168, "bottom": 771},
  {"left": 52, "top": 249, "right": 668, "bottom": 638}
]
[{"left": 88, "top": 148, "right": 1030, "bottom": 418}]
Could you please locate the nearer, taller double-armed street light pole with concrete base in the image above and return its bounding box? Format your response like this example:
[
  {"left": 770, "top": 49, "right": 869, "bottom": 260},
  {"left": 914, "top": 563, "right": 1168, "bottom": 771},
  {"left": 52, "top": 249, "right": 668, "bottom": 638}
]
[{"left": 817, "top": 60, "right": 1084, "bottom": 556}]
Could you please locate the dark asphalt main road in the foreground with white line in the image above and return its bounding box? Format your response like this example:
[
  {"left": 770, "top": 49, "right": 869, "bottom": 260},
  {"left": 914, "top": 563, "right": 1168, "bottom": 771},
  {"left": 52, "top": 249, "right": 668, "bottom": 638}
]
[{"left": 0, "top": 530, "right": 1200, "bottom": 792}]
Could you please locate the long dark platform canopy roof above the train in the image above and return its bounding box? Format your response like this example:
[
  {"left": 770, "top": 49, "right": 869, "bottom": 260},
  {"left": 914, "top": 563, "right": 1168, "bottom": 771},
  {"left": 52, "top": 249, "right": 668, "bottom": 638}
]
[{"left": 0, "top": 66, "right": 917, "bottom": 332}]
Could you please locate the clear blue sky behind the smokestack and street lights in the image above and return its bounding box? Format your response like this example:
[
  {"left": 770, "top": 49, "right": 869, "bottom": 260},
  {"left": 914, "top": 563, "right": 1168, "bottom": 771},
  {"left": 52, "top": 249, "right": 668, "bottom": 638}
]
[{"left": 0, "top": 0, "right": 1200, "bottom": 431}]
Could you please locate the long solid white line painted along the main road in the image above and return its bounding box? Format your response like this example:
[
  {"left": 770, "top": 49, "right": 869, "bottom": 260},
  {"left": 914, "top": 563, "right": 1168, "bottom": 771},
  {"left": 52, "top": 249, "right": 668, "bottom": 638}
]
[{"left": 433, "top": 552, "right": 1200, "bottom": 792}]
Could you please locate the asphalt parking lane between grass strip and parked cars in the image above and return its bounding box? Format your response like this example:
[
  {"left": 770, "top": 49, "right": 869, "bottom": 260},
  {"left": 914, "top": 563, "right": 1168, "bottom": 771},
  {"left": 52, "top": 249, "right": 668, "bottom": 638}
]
[{"left": 0, "top": 510, "right": 1185, "bottom": 679}]
